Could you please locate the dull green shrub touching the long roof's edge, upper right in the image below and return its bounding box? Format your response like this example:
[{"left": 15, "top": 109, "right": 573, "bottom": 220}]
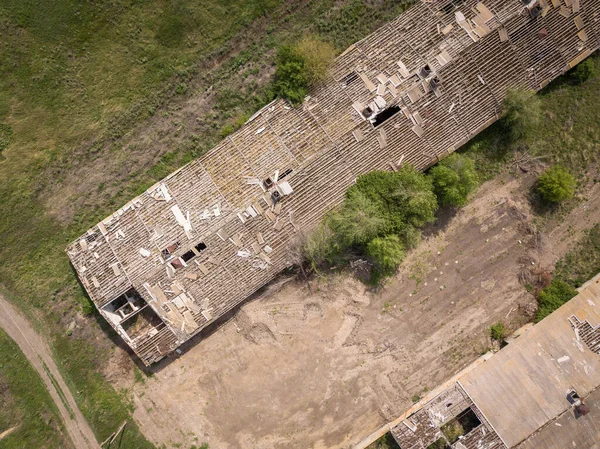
[{"left": 502, "top": 89, "right": 542, "bottom": 140}]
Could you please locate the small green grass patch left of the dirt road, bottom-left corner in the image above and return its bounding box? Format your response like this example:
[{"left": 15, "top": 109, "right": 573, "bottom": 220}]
[{"left": 0, "top": 330, "right": 72, "bottom": 449}]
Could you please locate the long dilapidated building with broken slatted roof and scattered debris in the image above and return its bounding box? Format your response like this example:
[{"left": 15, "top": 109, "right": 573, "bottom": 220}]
[{"left": 67, "top": 0, "right": 600, "bottom": 365}]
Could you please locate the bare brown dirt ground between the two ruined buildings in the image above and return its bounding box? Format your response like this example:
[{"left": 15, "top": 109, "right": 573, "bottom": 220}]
[{"left": 106, "top": 169, "right": 600, "bottom": 449}]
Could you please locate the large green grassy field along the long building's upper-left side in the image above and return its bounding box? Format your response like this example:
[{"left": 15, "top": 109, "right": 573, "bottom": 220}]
[{"left": 0, "top": 0, "right": 410, "bottom": 449}]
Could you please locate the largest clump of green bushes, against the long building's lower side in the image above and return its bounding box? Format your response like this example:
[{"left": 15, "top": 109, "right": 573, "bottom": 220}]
[{"left": 310, "top": 166, "right": 438, "bottom": 281}]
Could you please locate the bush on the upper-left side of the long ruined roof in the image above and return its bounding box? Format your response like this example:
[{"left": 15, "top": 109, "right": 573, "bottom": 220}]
[{"left": 273, "top": 37, "right": 335, "bottom": 105}]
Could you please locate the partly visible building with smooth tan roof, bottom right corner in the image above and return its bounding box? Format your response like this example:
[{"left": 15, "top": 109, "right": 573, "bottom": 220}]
[{"left": 389, "top": 275, "right": 600, "bottom": 449}]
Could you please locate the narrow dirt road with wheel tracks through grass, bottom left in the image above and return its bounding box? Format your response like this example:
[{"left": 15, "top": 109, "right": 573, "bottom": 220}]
[{"left": 0, "top": 295, "right": 100, "bottom": 449}]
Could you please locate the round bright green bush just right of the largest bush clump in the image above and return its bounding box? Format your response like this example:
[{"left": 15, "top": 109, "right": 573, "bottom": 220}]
[{"left": 429, "top": 153, "right": 479, "bottom": 206}]
